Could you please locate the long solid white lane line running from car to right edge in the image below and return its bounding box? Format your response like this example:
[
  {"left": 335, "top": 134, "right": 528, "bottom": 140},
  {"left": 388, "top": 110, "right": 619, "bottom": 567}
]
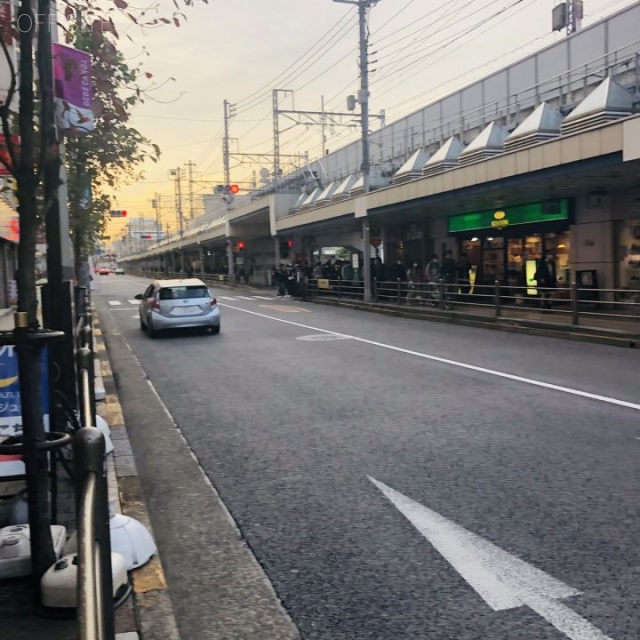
[{"left": 219, "top": 304, "right": 640, "bottom": 411}]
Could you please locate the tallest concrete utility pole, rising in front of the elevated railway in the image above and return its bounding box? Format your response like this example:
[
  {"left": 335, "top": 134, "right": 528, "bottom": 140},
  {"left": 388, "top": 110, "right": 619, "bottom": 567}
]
[{"left": 333, "top": 0, "right": 379, "bottom": 302}]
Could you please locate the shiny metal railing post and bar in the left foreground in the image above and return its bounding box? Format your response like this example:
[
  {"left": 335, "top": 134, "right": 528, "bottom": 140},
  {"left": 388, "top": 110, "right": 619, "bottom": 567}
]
[{"left": 73, "top": 289, "right": 115, "bottom": 640}]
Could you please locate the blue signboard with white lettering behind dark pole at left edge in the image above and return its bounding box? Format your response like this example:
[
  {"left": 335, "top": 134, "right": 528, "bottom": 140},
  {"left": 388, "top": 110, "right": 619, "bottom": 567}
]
[{"left": 0, "top": 346, "right": 49, "bottom": 478}]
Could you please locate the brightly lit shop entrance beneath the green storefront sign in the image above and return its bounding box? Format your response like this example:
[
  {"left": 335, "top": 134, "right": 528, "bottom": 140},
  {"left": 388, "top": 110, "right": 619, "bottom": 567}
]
[{"left": 460, "top": 231, "right": 570, "bottom": 288}]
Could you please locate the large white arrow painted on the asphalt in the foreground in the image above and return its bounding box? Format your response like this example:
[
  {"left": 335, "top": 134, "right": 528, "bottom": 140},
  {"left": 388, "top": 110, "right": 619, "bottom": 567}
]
[{"left": 367, "top": 476, "right": 611, "bottom": 640}]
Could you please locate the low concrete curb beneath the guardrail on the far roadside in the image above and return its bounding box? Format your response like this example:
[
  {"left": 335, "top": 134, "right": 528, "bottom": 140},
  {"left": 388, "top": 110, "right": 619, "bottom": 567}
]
[{"left": 308, "top": 298, "right": 640, "bottom": 349}]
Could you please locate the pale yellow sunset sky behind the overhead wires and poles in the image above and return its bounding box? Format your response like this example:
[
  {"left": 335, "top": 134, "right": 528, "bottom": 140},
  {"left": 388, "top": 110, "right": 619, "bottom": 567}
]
[{"left": 104, "top": 0, "right": 633, "bottom": 234}]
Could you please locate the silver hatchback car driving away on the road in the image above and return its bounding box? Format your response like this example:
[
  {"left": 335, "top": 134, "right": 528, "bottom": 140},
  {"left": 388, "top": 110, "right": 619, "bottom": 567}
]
[{"left": 136, "top": 278, "right": 220, "bottom": 338}]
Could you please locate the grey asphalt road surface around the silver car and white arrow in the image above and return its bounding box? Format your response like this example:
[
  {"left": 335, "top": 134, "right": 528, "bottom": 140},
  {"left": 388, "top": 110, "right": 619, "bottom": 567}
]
[{"left": 96, "top": 276, "right": 640, "bottom": 640}]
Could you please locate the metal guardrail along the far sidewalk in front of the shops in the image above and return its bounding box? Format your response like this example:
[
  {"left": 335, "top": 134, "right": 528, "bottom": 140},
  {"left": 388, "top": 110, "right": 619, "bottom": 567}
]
[{"left": 305, "top": 278, "right": 640, "bottom": 332}]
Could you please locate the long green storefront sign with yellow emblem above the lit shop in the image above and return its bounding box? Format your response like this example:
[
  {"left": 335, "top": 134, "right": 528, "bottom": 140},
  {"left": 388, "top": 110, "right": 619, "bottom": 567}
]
[{"left": 449, "top": 200, "right": 569, "bottom": 233}]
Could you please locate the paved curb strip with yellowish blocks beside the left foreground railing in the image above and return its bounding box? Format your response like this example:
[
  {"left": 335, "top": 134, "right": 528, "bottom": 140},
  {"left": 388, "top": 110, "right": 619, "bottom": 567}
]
[{"left": 94, "top": 315, "right": 180, "bottom": 640}]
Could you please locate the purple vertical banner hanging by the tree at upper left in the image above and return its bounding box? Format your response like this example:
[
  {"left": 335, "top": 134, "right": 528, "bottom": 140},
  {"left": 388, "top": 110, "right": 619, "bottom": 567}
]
[{"left": 53, "top": 43, "right": 94, "bottom": 135}]
